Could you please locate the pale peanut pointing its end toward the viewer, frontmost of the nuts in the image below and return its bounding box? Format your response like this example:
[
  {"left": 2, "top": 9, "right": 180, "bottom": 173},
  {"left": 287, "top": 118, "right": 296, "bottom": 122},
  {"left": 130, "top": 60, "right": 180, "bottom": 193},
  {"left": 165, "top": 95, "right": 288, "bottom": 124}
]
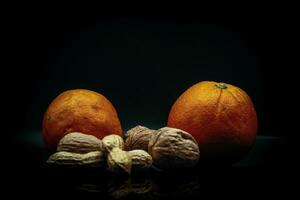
[{"left": 107, "top": 148, "right": 132, "bottom": 174}]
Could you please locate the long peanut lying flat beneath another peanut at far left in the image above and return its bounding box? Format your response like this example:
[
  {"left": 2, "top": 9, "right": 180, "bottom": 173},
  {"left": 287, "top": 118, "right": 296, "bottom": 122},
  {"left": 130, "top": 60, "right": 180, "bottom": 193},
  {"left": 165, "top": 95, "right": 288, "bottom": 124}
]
[{"left": 47, "top": 151, "right": 103, "bottom": 165}]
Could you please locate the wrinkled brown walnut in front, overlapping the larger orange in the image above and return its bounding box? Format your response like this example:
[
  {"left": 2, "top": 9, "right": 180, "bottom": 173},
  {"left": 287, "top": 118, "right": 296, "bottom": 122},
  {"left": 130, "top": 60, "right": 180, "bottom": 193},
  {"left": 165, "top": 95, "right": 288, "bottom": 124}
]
[{"left": 148, "top": 127, "right": 200, "bottom": 169}]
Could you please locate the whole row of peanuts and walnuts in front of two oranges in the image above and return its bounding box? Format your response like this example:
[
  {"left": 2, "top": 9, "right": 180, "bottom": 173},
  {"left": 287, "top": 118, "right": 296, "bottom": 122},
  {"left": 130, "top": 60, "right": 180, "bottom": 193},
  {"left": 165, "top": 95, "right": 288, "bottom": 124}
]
[{"left": 47, "top": 126, "right": 200, "bottom": 174}]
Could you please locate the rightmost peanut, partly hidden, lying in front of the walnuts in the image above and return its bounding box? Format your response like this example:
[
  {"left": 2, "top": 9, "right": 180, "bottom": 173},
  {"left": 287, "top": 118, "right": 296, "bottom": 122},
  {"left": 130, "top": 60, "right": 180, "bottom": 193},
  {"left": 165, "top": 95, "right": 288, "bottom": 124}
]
[{"left": 128, "top": 150, "right": 152, "bottom": 170}]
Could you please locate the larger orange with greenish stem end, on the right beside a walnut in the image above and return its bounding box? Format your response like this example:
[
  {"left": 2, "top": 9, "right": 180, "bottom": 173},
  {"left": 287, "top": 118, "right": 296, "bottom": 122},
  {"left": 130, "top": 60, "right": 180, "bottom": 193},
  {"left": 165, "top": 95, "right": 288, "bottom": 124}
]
[{"left": 168, "top": 81, "right": 257, "bottom": 162}]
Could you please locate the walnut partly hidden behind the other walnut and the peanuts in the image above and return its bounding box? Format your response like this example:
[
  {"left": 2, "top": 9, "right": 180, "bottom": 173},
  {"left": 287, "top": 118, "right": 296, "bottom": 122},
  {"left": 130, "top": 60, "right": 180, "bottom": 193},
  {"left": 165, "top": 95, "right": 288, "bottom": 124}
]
[{"left": 124, "top": 125, "right": 157, "bottom": 151}]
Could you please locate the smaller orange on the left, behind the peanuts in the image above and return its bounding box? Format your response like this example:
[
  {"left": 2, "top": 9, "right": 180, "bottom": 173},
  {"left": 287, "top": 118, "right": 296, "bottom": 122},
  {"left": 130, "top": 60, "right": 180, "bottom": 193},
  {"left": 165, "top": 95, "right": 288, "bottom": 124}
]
[{"left": 43, "top": 89, "right": 122, "bottom": 149}]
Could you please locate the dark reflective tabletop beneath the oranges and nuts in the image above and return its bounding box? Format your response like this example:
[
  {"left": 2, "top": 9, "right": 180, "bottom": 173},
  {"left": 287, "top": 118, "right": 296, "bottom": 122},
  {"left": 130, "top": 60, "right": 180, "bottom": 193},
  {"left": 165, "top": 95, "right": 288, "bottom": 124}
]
[{"left": 10, "top": 131, "right": 290, "bottom": 199}]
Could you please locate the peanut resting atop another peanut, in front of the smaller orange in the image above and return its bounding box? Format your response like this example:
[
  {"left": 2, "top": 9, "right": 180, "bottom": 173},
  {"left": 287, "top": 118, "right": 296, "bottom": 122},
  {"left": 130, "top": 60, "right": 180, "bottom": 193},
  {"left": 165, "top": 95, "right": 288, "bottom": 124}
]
[{"left": 57, "top": 132, "right": 103, "bottom": 153}]
